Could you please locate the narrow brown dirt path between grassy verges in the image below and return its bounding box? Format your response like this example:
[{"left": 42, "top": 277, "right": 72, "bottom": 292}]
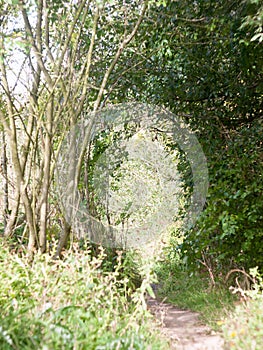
[{"left": 147, "top": 298, "right": 223, "bottom": 350}]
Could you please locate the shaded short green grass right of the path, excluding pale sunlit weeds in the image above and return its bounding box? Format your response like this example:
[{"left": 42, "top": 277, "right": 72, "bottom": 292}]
[{"left": 157, "top": 262, "right": 235, "bottom": 330}]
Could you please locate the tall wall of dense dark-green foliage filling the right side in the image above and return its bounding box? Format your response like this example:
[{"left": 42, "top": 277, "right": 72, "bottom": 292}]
[{"left": 124, "top": 0, "right": 263, "bottom": 271}]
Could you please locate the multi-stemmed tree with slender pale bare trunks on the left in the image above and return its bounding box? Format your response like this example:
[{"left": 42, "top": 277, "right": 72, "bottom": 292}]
[{"left": 0, "top": 0, "right": 152, "bottom": 258}]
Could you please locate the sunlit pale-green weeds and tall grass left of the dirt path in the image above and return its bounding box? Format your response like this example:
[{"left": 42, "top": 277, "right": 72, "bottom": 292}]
[{"left": 0, "top": 243, "right": 169, "bottom": 350}]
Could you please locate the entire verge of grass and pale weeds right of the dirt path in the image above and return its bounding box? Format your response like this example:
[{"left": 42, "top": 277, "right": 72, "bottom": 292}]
[{"left": 156, "top": 254, "right": 263, "bottom": 350}]
